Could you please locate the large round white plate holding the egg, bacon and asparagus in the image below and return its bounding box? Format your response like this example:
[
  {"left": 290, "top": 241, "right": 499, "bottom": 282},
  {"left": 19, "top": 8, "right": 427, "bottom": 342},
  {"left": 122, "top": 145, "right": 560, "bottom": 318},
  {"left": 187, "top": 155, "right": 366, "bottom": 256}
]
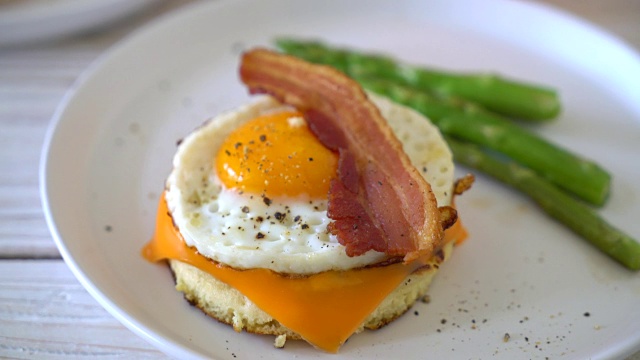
[{"left": 41, "top": 0, "right": 640, "bottom": 359}]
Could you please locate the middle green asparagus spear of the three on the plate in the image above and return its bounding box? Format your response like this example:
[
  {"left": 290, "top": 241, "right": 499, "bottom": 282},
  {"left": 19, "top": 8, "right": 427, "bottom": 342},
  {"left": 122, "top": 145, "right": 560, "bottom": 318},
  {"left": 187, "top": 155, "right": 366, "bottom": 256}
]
[{"left": 356, "top": 78, "right": 611, "bottom": 205}]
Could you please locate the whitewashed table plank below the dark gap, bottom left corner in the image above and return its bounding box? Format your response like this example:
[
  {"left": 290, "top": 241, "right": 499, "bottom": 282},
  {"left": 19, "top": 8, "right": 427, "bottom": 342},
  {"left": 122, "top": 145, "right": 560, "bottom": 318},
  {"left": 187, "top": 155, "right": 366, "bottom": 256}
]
[{"left": 0, "top": 260, "right": 167, "bottom": 359}]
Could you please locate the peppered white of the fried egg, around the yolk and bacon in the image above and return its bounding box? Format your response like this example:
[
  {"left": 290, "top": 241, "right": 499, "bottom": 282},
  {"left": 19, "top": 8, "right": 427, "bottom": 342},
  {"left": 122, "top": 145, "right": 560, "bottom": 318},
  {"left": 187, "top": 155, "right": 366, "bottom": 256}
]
[{"left": 165, "top": 94, "right": 454, "bottom": 274}]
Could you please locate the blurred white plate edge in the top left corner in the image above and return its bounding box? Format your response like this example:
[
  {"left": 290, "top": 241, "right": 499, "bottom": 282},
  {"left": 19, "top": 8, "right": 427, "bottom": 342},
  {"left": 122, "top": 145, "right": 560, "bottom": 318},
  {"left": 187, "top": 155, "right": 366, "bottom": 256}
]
[{"left": 0, "top": 0, "right": 155, "bottom": 46}]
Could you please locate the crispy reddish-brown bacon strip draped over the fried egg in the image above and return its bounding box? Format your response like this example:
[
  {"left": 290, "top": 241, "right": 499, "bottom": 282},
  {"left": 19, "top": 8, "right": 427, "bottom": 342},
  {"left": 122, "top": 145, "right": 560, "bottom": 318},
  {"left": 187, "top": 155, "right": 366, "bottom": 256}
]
[{"left": 240, "top": 49, "right": 443, "bottom": 262}]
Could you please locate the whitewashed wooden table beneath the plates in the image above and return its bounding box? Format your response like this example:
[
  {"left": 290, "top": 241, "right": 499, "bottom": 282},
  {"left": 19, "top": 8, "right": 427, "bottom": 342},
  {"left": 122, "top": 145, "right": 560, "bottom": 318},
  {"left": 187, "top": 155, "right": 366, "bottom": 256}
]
[{"left": 0, "top": 0, "right": 640, "bottom": 360}]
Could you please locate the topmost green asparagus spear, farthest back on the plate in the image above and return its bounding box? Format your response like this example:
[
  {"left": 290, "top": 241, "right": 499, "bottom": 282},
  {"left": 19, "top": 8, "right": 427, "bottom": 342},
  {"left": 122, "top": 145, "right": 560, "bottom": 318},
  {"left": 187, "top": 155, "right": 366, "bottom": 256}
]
[{"left": 276, "top": 39, "right": 560, "bottom": 120}]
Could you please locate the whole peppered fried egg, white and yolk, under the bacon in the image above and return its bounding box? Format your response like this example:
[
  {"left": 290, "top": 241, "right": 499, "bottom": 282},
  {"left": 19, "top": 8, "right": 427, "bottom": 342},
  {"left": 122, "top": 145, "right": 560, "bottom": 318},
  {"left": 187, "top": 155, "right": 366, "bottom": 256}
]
[{"left": 165, "top": 94, "right": 454, "bottom": 275}]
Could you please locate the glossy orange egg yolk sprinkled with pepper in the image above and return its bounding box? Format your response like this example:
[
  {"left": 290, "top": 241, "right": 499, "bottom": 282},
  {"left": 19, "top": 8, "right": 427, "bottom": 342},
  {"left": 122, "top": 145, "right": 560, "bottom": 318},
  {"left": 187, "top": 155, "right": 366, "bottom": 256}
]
[{"left": 216, "top": 112, "right": 338, "bottom": 199}]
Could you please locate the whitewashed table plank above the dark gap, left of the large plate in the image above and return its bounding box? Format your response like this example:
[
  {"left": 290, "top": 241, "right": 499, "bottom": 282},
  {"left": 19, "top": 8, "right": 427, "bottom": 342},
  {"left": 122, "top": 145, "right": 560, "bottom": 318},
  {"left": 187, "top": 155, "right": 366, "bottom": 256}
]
[{"left": 0, "top": 0, "right": 199, "bottom": 258}]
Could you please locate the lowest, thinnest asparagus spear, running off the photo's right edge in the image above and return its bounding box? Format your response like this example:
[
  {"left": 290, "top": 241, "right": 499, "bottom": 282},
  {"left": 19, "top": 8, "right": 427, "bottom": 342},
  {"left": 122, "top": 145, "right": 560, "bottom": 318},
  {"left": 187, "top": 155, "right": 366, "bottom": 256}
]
[{"left": 447, "top": 138, "right": 640, "bottom": 270}]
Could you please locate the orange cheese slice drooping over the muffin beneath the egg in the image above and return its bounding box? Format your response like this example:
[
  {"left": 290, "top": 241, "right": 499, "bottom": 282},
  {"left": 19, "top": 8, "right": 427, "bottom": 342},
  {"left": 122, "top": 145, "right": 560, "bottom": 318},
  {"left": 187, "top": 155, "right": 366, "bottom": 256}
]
[{"left": 143, "top": 196, "right": 464, "bottom": 352}]
